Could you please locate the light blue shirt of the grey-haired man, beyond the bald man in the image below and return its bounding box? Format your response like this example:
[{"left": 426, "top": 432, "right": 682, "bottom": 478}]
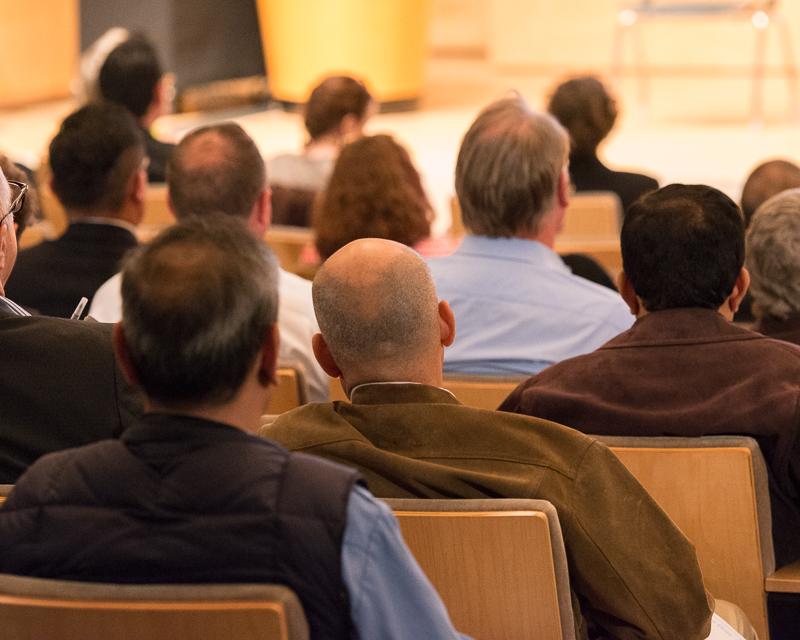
[{"left": 430, "top": 236, "right": 634, "bottom": 375}]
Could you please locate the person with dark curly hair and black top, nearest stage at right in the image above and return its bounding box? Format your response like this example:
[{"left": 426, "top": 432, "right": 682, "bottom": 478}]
[{"left": 547, "top": 76, "right": 658, "bottom": 212}]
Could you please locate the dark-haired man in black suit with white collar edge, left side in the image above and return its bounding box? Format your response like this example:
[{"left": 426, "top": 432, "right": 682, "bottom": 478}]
[{"left": 8, "top": 104, "right": 147, "bottom": 318}]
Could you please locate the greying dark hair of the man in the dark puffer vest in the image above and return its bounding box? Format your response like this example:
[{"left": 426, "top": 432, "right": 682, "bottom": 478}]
[{"left": 122, "top": 215, "right": 278, "bottom": 407}]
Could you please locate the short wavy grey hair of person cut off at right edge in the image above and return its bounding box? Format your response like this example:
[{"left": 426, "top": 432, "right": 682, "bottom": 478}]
[{"left": 746, "top": 189, "right": 800, "bottom": 320}]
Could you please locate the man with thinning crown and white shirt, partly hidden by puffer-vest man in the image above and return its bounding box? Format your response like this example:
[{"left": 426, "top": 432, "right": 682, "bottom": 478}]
[{"left": 89, "top": 122, "right": 329, "bottom": 401}]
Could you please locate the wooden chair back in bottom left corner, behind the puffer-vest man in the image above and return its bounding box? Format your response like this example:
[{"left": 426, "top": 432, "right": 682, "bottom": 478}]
[{"left": 0, "top": 575, "right": 308, "bottom": 640}]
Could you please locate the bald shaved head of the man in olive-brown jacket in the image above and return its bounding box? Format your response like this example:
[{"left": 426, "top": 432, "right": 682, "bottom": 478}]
[{"left": 313, "top": 239, "right": 439, "bottom": 381}]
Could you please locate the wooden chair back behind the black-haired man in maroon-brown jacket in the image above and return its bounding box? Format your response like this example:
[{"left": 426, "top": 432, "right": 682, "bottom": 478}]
[{"left": 599, "top": 436, "right": 775, "bottom": 638}]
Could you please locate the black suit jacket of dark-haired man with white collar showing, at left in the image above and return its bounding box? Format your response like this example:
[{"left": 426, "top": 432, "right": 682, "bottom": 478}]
[{"left": 6, "top": 222, "right": 137, "bottom": 318}]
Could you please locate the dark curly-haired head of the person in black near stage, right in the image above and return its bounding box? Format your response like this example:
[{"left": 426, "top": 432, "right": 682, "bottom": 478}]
[{"left": 547, "top": 76, "right": 617, "bottom": 155}]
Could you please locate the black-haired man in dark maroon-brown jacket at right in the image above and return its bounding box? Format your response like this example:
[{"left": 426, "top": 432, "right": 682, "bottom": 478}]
[{"left": 500, "top": 185, "right": 800, "bottom": 566}]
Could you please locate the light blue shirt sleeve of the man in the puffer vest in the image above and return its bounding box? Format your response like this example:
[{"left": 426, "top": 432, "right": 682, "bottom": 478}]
[{"left": 342, "top": 486, "right": 468, "bottom": 640}]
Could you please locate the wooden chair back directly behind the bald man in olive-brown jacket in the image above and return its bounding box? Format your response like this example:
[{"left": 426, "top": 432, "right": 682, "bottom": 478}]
[{"left": 386, "top": 499, "right": 575, "bottom": 640}]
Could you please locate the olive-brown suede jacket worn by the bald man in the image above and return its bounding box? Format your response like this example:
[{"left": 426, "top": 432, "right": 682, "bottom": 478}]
[{"left": 261, "top": 384, "right": 711, "bottom": 640}]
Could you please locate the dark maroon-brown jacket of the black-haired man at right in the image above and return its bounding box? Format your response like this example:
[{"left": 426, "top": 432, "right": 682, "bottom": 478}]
[{"left": 500, "top": 309, "right": 800, "bottom": 566}]
